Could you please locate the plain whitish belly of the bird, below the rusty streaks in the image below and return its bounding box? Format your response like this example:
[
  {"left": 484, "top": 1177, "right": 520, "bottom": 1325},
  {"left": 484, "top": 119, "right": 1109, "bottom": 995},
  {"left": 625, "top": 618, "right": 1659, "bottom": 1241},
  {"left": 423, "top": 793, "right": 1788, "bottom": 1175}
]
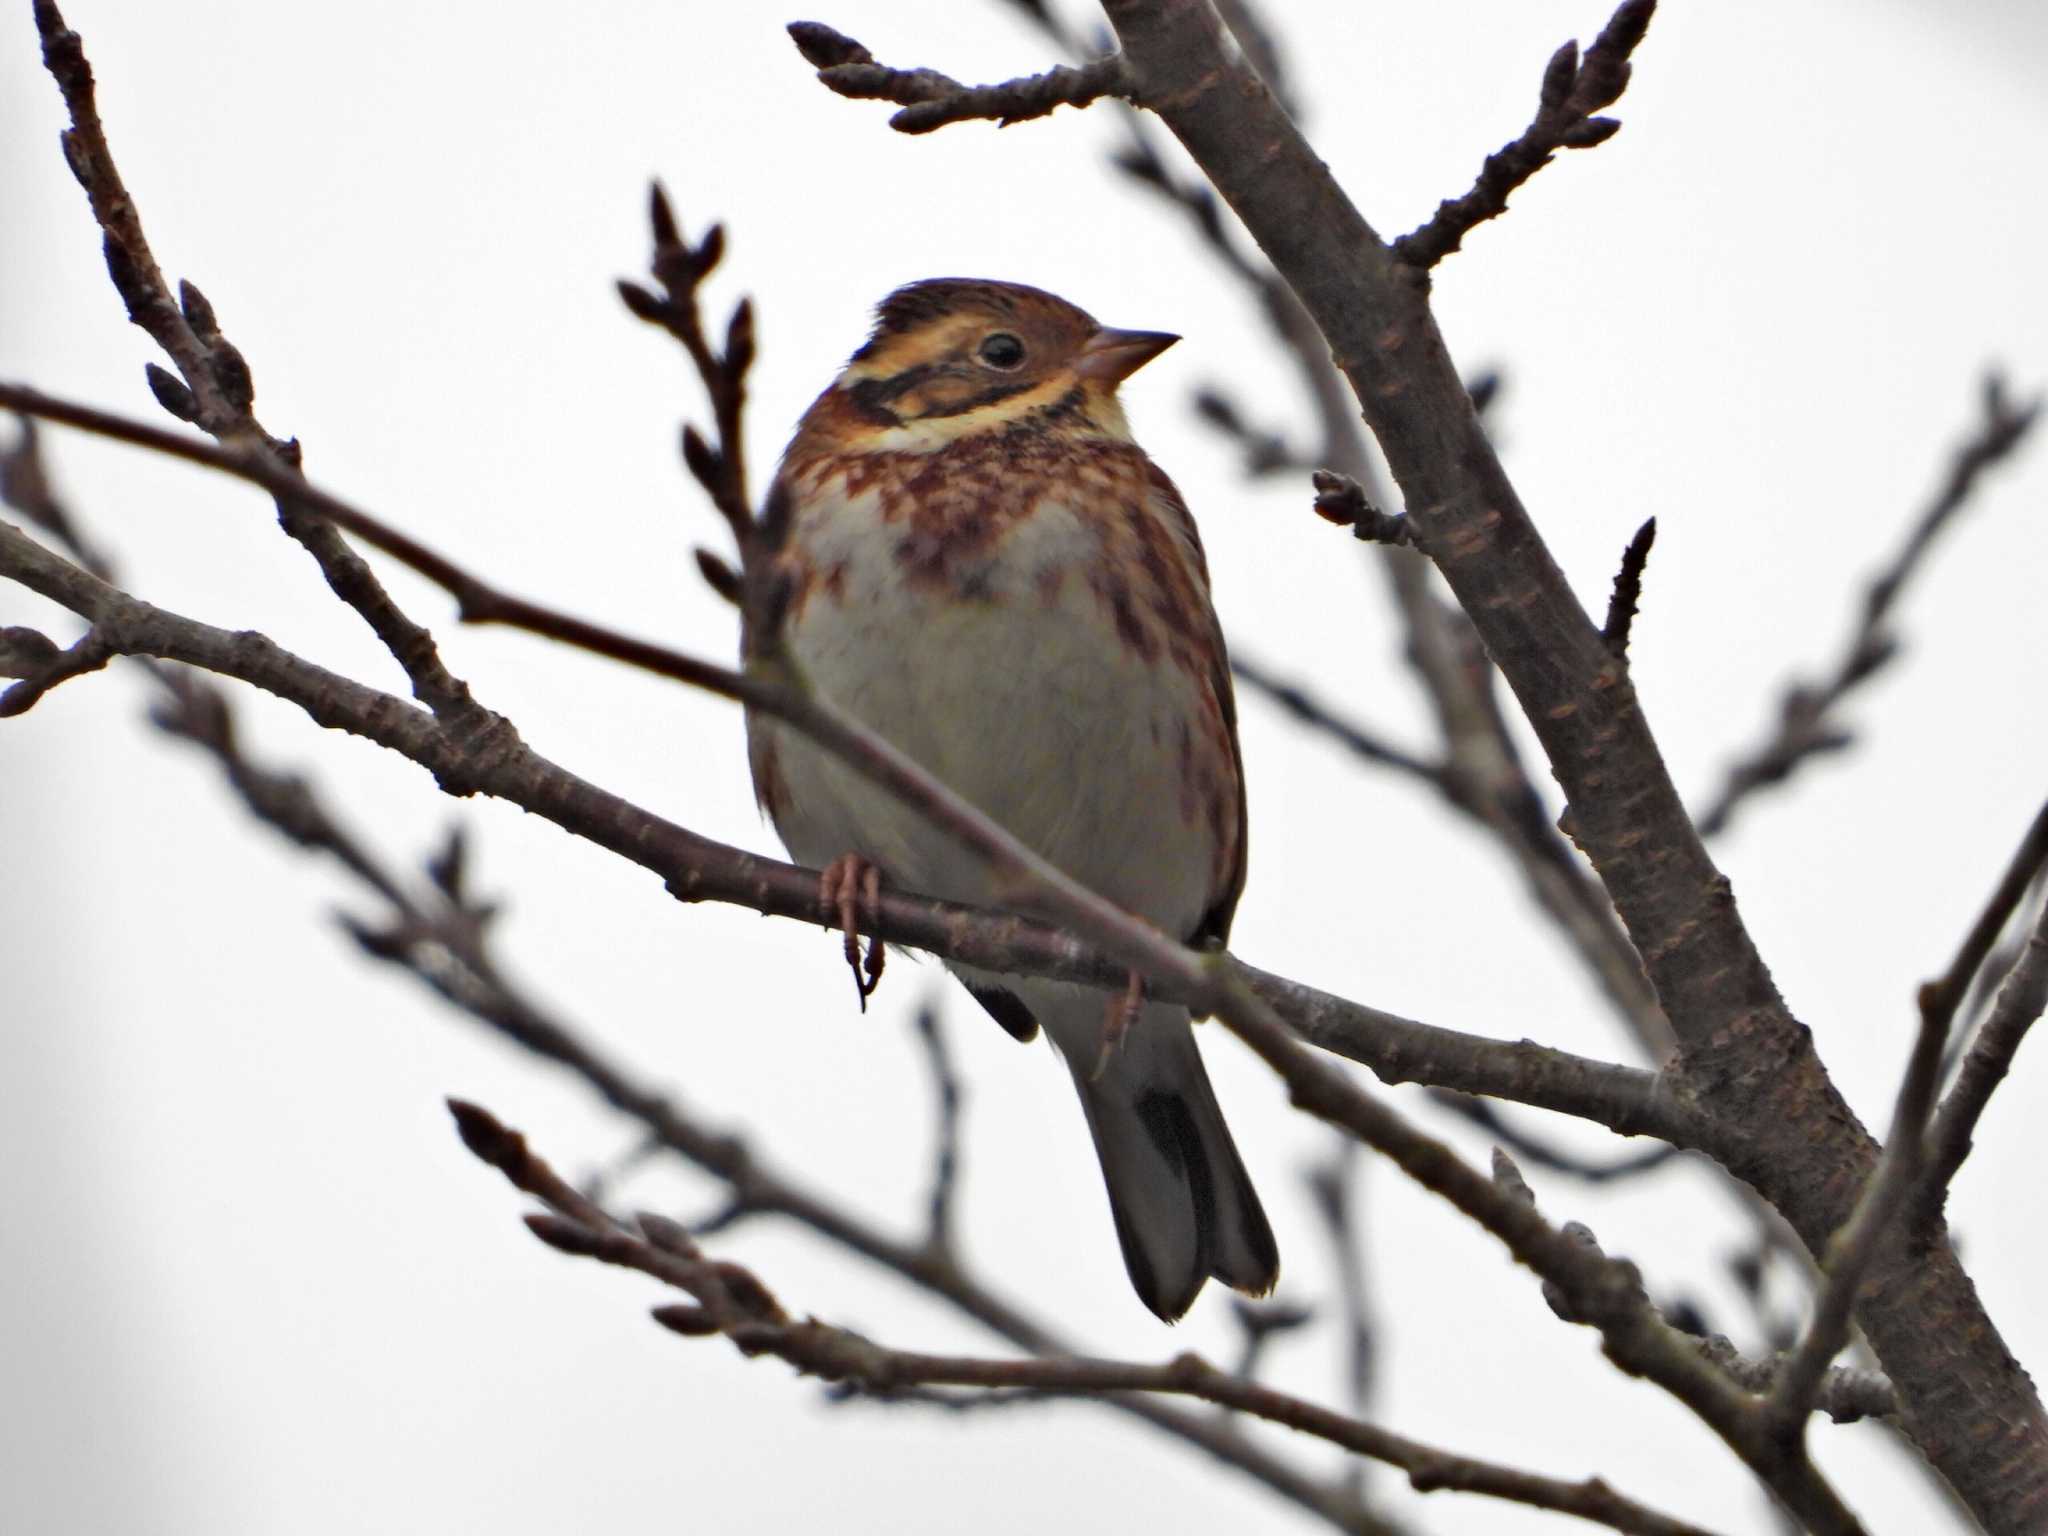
[{"left": 750, "top": 487, "right": 1235, "bottom": 936}]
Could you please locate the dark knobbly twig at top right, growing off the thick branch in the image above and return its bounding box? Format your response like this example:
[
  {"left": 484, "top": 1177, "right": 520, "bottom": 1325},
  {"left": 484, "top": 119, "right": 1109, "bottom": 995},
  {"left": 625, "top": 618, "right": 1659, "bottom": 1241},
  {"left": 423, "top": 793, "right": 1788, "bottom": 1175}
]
[{"left": 1393, "top": 0, "right": 1657, "bottom": 270}]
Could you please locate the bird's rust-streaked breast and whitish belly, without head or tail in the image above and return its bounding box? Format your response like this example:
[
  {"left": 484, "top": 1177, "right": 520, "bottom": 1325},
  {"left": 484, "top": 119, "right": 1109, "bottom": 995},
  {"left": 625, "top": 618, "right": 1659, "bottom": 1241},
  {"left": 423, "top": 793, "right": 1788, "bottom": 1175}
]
[{"left": 750, "top": 436, "right": 1241, "bottom": 934}]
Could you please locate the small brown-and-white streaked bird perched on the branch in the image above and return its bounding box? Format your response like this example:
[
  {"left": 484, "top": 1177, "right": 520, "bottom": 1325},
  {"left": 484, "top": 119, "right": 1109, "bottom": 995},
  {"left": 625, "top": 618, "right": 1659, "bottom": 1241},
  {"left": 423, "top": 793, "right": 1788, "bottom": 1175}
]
[{"left": 743, "top": 279, "right": 1280, "bottom": 1323}]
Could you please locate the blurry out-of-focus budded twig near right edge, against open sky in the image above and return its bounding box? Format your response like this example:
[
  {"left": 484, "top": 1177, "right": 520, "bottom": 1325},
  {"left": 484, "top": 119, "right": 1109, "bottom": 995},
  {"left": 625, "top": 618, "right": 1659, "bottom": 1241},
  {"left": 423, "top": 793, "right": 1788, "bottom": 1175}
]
[{"left": 1700, "top": 373, "right": 2042, "bottom": 838}]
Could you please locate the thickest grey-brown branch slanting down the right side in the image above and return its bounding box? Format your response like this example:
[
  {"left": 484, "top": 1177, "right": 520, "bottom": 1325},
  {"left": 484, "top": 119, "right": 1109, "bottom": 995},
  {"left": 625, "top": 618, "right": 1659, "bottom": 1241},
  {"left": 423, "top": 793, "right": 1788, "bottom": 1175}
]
[{"left": 1064, "top": 0, "right": 2048, "bottom": 1530}]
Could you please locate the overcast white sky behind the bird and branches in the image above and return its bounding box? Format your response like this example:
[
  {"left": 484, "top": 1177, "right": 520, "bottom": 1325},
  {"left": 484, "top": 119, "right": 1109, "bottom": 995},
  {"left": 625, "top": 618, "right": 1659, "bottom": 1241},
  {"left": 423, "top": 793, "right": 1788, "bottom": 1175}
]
[{"left": 0, "top": 0, "right": 2048, "bottom": 1536}]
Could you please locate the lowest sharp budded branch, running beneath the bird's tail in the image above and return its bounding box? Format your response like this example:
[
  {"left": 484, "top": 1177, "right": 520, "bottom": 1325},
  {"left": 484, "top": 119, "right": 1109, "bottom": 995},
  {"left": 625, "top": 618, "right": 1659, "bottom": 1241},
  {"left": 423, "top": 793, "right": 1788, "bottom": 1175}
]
[{"left": 460, "top": 1100, "right": 1728, "bottom": 1536}]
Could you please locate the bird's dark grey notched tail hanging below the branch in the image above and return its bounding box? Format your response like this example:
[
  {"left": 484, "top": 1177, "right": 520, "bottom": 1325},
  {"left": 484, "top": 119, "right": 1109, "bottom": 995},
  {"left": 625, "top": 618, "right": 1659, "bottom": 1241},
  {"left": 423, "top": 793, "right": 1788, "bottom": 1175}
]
[{"left": 1063, "top": 993, "right": 1280, "bottom": 1323}]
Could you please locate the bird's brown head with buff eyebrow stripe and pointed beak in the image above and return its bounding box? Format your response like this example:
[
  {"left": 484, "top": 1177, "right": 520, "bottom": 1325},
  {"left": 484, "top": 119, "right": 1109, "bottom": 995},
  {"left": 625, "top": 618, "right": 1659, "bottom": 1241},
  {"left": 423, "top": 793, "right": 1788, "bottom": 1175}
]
[{"left": 813, "top": 276, "right": 1180, "bottom": 453}]
